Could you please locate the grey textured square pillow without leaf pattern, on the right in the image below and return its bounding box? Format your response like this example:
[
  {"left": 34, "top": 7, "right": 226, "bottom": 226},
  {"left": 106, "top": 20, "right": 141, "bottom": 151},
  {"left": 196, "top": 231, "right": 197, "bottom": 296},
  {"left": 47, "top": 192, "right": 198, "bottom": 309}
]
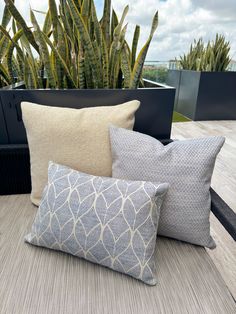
[{"left": 110, "top": 126, "right": 225, "bottom": 248}]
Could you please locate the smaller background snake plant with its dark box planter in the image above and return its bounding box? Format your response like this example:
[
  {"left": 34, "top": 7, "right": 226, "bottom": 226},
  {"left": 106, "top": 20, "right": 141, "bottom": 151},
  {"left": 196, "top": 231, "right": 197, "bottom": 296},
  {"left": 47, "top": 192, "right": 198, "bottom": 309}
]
[{"left": 168, "top": 34, "right": 236, "bottom": 120}]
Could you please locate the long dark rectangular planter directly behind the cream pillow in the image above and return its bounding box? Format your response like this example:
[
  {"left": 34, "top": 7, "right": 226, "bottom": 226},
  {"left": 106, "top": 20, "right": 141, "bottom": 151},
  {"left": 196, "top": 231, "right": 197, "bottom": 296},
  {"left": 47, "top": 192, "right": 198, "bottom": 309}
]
[{"left": 0, "top": 83, "right": 175, "bottom": 144}]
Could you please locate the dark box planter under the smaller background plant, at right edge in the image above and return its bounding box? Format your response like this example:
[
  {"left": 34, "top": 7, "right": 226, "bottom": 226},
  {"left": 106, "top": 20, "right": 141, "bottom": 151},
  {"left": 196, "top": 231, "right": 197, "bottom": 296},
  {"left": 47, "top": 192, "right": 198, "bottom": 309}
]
[{"left": 168, "top": 70, "right": 236, "bottom": 121}]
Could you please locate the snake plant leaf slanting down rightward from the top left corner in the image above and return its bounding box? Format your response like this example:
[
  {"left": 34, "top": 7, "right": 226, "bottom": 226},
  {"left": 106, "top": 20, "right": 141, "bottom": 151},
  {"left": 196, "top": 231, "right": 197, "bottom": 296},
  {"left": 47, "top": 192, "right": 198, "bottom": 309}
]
[{"left": 4, "top": 0, "right": 39, "bottom": 52}]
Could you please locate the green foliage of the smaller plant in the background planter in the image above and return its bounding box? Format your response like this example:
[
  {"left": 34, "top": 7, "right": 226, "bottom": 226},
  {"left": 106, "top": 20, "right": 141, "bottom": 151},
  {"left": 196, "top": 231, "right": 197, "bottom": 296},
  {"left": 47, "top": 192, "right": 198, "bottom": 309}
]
[{"left": 180, "top": 34, "right": 231, "bottom": 72}]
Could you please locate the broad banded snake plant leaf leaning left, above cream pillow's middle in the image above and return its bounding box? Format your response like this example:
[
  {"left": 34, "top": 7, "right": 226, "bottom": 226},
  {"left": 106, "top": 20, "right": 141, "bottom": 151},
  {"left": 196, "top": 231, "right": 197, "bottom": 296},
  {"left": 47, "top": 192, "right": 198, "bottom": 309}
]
[{"left": 68, "top": 0, "right": 102, "bottom": 88}]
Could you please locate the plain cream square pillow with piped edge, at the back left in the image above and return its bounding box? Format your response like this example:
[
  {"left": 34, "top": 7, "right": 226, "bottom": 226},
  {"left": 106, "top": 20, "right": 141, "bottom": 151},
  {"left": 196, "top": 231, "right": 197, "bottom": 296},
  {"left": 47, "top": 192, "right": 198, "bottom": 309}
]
[{"left": 21, "top": 100, "right": 140, "bottom": 205}]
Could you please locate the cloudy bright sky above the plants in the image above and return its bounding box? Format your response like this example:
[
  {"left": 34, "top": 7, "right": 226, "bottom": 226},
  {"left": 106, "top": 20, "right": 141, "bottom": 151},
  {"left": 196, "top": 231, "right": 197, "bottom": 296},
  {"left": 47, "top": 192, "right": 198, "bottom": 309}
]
[{"left": 0, "top": 0, "right": 236, "bottom": 61}]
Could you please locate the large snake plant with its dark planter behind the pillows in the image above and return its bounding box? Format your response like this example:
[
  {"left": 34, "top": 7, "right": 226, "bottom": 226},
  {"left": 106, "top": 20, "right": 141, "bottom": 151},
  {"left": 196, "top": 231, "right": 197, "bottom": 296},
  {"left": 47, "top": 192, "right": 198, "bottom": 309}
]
[{"left": 0, "top": 0, "right": 175, "bottom": 144}]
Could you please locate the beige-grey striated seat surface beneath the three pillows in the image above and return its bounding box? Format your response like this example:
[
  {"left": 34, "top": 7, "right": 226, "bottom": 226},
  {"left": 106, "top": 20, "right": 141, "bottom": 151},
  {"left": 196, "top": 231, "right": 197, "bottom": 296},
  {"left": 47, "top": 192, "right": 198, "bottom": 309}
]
[{"left": 0, "top": 195, "right": 236, "bottom": 314}]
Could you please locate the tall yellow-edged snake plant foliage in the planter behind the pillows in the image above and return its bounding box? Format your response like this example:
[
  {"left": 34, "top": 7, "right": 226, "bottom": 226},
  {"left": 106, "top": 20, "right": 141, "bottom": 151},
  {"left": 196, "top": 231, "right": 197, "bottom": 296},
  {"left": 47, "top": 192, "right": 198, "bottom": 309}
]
[{"left": 0, "top": 0, "right": 158, "bottom": 88}]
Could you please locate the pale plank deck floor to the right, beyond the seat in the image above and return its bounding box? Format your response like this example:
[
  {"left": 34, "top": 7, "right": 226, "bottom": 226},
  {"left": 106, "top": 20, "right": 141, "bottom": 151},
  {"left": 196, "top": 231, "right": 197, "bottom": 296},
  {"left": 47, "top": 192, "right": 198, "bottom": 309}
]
[{"left": 171, "top": 121, "right": 236, "bottom": 299}]
